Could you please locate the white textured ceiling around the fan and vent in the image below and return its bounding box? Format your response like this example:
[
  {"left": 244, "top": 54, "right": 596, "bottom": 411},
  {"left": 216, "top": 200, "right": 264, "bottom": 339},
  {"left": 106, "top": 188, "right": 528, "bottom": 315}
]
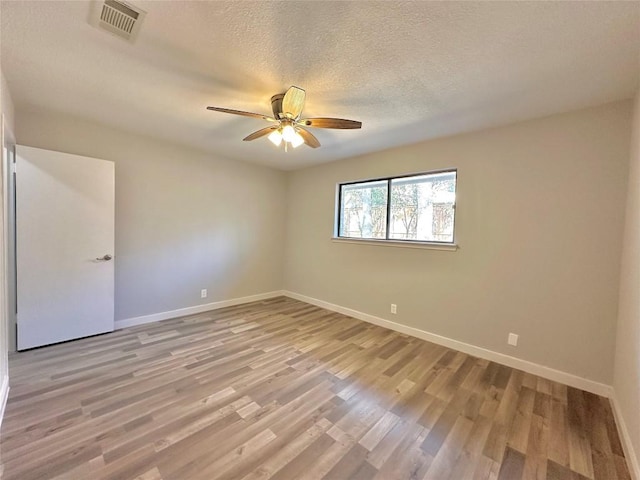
[{"left": 0, "top": 0, "right": 640, "bottom": 169}]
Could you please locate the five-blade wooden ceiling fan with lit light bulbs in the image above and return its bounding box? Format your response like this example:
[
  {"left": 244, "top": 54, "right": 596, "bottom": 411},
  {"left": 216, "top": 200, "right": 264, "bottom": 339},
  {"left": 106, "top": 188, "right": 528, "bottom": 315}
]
[{"left": 207, "top": 87, "right": 362, "bottom": 151}]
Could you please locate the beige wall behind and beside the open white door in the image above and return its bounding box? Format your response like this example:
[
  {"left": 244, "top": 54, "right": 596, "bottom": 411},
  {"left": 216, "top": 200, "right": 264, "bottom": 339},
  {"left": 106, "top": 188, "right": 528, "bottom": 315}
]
[{"left": 16, "top": 108, "right": 286, "bottom": 326}]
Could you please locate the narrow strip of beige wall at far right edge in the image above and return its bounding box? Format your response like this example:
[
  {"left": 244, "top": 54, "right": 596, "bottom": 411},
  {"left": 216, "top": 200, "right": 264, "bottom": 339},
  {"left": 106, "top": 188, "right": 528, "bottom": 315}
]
[{"left": 613, "top": 92, "right": 640, "bottom": 478}]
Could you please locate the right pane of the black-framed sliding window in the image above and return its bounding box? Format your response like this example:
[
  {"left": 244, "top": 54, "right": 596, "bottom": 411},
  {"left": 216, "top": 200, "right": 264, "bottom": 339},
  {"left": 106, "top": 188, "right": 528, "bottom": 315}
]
[{"left": 389, "top": 172, "right": 456, "bottom": 243}]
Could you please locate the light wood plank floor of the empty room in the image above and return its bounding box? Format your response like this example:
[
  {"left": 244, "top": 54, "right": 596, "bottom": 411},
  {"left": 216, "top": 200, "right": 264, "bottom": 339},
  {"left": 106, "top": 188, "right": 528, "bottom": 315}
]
[{"left": 0, "top": 298, "right": 630, "bottom": 480}]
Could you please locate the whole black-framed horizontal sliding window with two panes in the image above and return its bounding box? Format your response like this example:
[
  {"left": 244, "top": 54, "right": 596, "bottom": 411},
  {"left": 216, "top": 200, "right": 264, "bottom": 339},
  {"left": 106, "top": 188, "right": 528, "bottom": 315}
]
[{"left": 337, "top": 170, "right": 457, "bottom": 243}]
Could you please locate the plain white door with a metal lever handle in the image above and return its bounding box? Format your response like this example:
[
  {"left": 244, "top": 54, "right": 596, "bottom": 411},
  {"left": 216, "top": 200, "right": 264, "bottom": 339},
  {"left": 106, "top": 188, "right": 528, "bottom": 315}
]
[{"left": 16, "top": 145, "right": 115, "bottom": 350}]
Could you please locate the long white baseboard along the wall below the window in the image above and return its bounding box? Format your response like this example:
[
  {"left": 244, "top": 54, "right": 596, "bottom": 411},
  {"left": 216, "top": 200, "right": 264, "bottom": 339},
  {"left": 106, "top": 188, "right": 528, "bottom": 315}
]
[{"left": 283, "top": 290, "right": 612, "bottom": 398}]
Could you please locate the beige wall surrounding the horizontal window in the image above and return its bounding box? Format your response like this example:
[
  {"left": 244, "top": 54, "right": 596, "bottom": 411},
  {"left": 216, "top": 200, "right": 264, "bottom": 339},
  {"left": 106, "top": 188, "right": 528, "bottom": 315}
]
[{"left": 285, "top": 102, "right": 631, "bottom": 384}]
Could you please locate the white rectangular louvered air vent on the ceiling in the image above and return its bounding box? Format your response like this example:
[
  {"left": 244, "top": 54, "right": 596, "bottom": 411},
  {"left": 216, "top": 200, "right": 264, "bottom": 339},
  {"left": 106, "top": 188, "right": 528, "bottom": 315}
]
[{"left": 91, "top": 0, "right": 147, "bottom": 42}]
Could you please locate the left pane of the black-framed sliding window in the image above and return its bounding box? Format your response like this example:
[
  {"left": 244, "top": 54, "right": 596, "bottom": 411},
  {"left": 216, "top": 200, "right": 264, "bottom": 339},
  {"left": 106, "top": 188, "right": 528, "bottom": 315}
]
[{"left": 338, "top": 180, "right": 387, "bottom": 238}]
